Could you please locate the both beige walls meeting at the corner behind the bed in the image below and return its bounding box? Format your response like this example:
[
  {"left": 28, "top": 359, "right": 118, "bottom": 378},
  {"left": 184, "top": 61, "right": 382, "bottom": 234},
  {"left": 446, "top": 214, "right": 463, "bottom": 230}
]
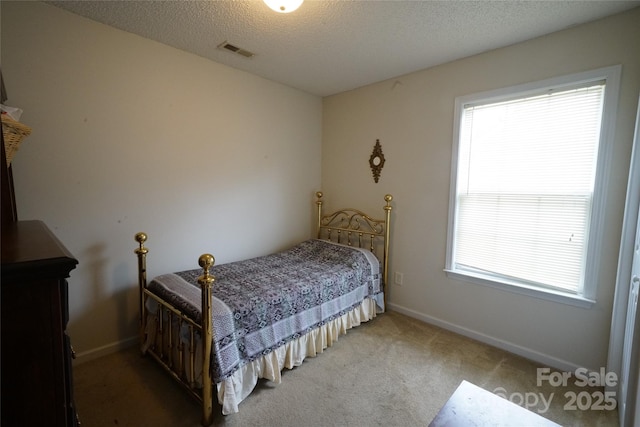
[{"left": 1, "top": 2, "right": 640, "bottom": 374}]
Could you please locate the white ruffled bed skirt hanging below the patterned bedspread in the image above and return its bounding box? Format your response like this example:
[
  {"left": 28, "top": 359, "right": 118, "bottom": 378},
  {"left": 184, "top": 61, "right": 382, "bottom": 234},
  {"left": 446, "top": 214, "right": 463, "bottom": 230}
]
[{"left": 216, "top": 298, "right": 378, "bottom": 415}]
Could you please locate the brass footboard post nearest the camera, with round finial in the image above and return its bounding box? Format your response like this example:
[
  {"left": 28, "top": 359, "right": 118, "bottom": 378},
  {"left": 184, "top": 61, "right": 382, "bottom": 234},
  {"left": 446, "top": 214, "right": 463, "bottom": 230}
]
[{"left": 198, "top": 254, "right": 216, "bottom": 426}]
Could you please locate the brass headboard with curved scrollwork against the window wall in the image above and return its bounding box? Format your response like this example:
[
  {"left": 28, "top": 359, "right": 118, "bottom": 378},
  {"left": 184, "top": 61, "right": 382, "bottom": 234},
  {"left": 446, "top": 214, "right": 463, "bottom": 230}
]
[{"left": 316, "top": 191, "right": 393, "bottom": 289}]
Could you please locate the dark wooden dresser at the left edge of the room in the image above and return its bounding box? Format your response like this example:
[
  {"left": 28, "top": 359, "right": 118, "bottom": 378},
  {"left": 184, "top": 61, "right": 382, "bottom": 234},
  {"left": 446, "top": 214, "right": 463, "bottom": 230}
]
[{"left": 0, "top": 124, "right": 78, "bottom": 427}]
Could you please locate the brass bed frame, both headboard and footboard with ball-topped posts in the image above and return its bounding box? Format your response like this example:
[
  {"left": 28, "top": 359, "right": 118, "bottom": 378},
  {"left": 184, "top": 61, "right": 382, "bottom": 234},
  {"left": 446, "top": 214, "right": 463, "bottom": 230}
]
[{"left": 134, "top": 191, "right": 393, "bottom": 426}]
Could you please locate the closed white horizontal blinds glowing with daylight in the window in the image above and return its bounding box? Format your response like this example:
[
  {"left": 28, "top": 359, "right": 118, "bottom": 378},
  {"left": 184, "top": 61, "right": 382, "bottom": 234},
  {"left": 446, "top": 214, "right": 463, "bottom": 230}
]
[{"left": 453, "top": 81, "right": 605, "bottom": 294}]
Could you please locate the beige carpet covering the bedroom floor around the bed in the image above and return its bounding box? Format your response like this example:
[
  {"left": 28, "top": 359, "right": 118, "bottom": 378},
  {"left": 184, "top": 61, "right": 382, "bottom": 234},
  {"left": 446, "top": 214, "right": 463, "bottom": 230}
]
[{"left": 75, "top": 312, "right": 618, "bottom": 427}]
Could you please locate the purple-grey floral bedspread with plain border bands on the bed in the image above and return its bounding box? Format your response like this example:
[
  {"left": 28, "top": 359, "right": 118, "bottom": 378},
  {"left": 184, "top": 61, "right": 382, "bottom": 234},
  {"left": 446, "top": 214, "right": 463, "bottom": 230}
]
[{"left": 148, "top": 239, "right": 384, "bottom": 382}]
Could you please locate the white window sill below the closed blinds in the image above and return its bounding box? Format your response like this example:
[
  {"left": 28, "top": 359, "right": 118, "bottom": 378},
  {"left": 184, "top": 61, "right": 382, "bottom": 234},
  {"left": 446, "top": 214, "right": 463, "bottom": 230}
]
[{"left": 445, "top": 269, "right": 595, "bottom": 308}]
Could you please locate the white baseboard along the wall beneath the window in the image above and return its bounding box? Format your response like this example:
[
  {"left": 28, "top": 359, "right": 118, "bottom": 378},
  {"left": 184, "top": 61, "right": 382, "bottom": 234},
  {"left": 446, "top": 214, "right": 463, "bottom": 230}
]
[{"left": 387, "top": 303, "right": 582, "bottom": 372}]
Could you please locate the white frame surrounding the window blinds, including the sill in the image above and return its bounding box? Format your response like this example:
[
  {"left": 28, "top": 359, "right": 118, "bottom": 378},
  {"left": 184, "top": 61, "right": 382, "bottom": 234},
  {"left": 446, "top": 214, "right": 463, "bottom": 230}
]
[{"left": 444, "top": 65, "right": 622, "bottom": 308}]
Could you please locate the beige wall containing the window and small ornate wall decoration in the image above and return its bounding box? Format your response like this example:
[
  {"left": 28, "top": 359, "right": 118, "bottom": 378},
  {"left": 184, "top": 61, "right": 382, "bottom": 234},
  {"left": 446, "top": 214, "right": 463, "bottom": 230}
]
[{"left": 322, "top": 8, "right": 640, "bottom": 369}]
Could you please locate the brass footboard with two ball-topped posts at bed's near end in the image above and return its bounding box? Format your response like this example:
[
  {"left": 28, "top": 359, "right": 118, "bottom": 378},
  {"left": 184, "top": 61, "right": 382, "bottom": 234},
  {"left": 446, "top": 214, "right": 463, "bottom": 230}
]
[{"left": 134, "top": 233, "right": 215, "bottom": 426}]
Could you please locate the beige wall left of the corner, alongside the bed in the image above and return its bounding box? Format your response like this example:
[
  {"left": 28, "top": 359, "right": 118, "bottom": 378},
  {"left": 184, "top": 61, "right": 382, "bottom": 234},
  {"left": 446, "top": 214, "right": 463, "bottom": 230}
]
[{"left": 1, "top": 2, "right": 322, "bottom": 359}]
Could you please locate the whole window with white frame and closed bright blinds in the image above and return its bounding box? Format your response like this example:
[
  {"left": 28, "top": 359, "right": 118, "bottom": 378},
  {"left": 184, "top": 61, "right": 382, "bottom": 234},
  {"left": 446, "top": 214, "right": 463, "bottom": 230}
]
[{"left": 446, "top": 66, "right": 620, "bottom": 306}]
